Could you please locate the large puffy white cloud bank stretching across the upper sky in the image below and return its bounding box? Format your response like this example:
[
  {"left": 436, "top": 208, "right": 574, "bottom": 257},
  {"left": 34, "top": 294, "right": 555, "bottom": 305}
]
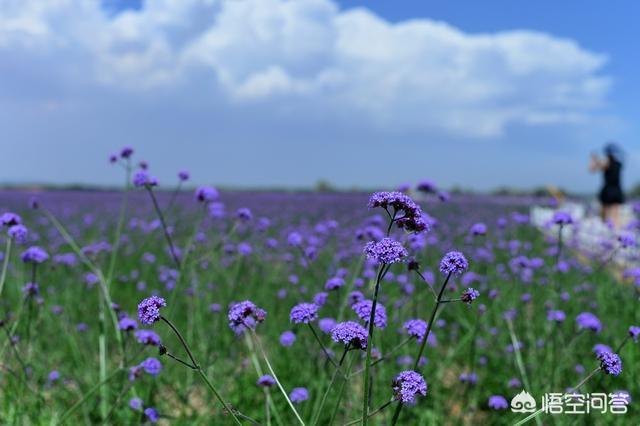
[{"left": 0, "top": 0, "right": 611, "bottom": 138}]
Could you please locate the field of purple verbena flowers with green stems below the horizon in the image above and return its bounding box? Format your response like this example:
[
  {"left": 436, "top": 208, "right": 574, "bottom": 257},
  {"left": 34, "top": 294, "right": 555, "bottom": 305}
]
[{"left": 0, "top": 150, "right": 640, "bottom": 425}]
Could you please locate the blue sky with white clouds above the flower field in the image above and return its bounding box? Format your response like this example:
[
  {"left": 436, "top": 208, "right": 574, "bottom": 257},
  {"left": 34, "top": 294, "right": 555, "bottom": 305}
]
[{"left": 0, "top": 0, "right": 640, "bottom": 192}]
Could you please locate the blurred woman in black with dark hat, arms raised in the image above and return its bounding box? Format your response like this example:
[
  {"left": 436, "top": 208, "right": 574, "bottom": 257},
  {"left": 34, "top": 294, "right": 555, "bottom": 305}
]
[{"left": 589, "top": 143, "right": 624, "bottom": 227}]
